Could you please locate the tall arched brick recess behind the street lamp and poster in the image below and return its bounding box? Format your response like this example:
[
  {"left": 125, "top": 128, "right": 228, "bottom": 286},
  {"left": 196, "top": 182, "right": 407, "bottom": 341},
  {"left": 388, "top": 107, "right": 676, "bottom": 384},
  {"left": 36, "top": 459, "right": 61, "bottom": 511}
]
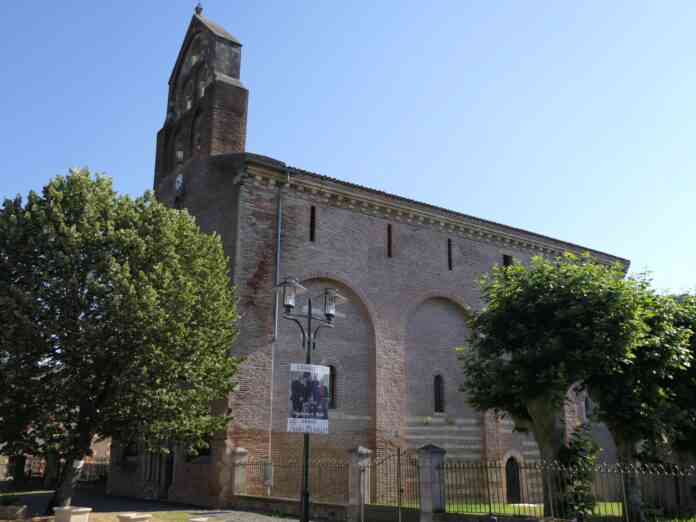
[{"left": 273, "top": 277, "right": 375, "bottom": 445}]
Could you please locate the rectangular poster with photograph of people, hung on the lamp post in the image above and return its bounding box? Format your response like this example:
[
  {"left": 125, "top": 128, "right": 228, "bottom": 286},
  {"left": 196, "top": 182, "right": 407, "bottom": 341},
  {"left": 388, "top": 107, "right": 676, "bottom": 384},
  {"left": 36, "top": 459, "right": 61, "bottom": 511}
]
[{"left": 288, "top": 364, "right": 330, "bottom": 433}]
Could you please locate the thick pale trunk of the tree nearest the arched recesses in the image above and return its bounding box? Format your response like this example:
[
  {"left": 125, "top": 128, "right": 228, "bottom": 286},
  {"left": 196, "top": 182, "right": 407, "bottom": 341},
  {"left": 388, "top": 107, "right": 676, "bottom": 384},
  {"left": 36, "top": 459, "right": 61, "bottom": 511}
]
[{"left": 527, "top": 398, "right": 565, "bottom": 517}]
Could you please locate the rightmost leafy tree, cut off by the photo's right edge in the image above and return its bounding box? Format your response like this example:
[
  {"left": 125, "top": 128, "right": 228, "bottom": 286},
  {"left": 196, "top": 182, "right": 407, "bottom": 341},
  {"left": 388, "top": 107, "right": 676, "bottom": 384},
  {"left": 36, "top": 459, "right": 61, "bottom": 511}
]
[{"left": 584, "top": 291, "right": 696, "bottom": 520}]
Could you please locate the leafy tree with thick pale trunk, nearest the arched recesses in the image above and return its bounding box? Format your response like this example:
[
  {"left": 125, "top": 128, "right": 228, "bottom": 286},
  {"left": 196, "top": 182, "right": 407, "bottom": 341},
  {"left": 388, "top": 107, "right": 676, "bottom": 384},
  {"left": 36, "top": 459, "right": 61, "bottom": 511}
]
[{"left": 461, "top": 254, "right": 648, "bottom": 512}]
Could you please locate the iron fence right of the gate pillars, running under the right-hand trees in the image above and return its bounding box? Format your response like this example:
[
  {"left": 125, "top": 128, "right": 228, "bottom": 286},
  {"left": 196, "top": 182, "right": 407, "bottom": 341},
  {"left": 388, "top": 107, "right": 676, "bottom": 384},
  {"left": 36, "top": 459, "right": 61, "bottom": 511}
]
[{"left": 440, "top": 460, "right": 696, "bottom": 522}]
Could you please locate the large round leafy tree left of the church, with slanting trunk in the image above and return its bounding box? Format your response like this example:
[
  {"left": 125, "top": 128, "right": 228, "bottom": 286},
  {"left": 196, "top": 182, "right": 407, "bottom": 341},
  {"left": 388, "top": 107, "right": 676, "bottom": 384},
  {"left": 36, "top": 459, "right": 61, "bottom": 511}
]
[{"left": 0, "top": 170, "right": 239, "bottom": 505}]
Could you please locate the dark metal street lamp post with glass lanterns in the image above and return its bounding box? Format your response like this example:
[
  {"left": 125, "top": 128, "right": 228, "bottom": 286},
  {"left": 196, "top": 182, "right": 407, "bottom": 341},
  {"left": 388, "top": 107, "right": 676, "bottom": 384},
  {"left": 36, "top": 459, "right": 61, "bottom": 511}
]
[{"left": 277, "top": 278, "right": 342, "bottom": 522}]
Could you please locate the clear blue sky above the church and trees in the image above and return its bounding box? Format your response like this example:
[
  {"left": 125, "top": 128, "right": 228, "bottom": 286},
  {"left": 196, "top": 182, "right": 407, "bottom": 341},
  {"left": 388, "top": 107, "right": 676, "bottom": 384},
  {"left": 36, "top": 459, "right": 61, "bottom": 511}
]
[{"left": 0, "top": 0, "right": 696, "bottom": 291}]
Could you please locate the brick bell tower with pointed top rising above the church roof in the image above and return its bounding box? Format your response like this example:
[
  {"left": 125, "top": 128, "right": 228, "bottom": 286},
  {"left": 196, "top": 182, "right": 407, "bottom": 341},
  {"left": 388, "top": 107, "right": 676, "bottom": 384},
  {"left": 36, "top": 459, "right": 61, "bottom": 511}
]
[{"left": 154, "top": 4, "right": 249, "bottom": 187}]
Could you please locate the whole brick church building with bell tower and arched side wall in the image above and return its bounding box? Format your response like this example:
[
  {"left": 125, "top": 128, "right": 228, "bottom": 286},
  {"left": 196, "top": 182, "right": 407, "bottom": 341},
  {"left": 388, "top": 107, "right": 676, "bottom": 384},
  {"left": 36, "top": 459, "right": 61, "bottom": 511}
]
[{"left": 109, "top": 10, "right": 628, "bottom": 506}]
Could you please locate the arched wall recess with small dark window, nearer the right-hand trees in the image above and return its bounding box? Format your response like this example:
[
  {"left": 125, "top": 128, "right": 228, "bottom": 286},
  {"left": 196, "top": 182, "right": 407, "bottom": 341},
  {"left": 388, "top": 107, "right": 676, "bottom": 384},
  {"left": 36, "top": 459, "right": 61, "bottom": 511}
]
[{"left": 405, "top": 297, "right": 477, "bottom": 422}]
